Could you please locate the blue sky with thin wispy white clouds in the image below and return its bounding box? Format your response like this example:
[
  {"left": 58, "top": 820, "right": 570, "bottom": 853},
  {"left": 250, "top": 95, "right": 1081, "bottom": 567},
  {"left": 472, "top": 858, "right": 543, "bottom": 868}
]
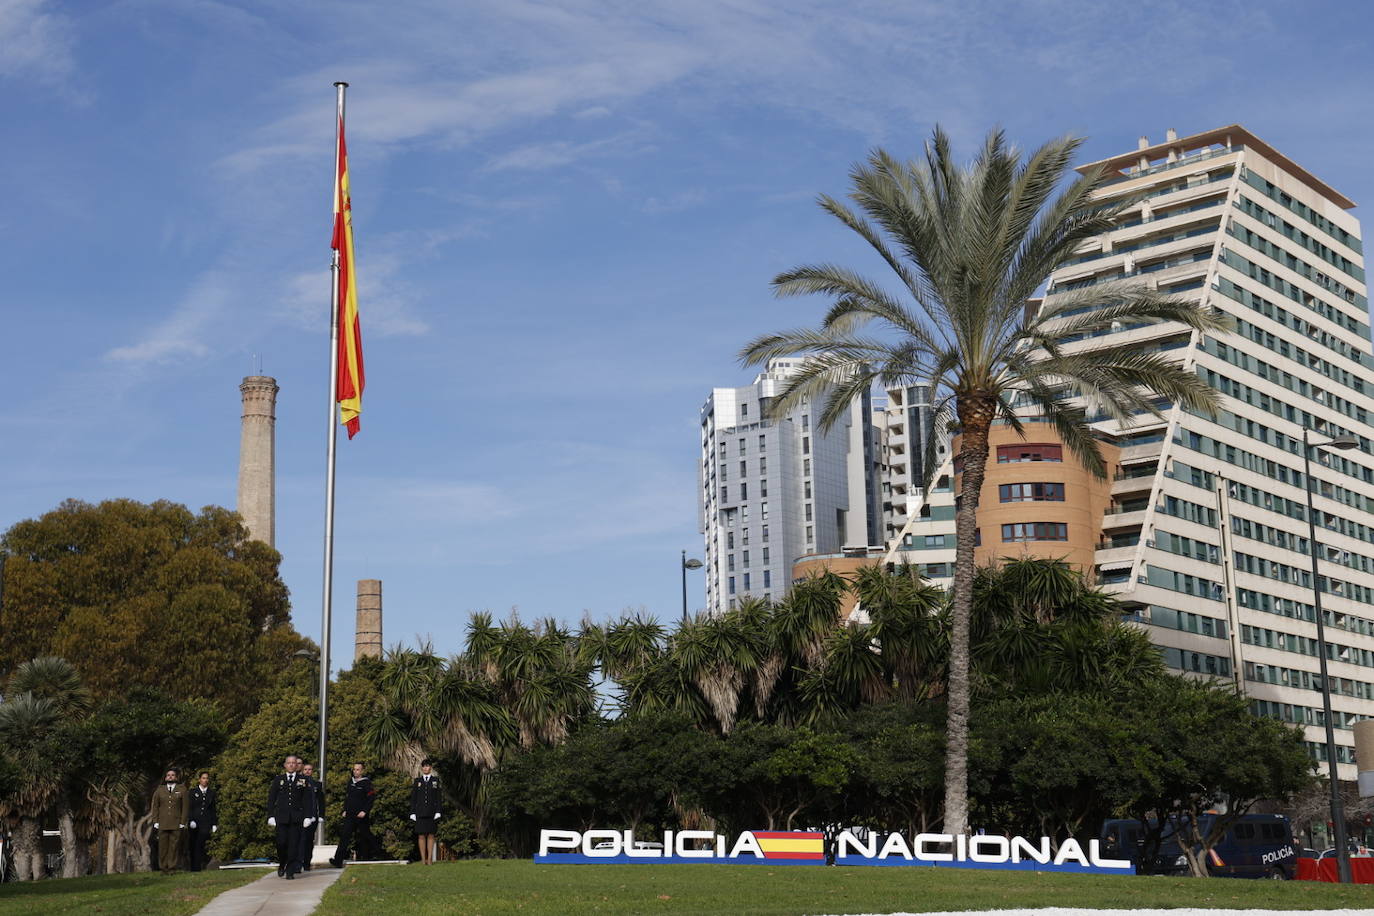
[{"left": 0, "top": 0, "right": 1374, "bottom": 661}]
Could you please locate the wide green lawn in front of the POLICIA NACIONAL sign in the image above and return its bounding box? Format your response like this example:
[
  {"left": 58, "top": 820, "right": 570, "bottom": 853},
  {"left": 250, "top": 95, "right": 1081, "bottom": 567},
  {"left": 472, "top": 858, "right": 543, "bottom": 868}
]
[{"left": 316, "top": 860, "right": 1374, "bottom": 916}]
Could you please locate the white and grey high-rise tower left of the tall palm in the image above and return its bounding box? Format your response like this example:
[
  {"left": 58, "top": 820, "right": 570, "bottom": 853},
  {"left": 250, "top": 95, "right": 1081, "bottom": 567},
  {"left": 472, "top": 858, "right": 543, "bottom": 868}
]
[{"left": 698, "top": 357, "right": 881, "bottom": 614}]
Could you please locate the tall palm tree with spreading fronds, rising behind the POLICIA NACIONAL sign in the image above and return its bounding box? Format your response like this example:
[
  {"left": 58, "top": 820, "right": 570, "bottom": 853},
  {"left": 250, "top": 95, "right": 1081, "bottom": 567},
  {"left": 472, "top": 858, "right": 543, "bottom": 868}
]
[{"left": 741, "top": 128, "right": 1224, "bottom": 834}]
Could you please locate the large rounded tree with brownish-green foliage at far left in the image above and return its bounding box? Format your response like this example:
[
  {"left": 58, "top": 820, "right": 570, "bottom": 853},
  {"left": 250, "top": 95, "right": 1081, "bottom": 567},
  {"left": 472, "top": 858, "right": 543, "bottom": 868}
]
[{"left": 0, "top": 500, "right": 306, "bottom": 725}]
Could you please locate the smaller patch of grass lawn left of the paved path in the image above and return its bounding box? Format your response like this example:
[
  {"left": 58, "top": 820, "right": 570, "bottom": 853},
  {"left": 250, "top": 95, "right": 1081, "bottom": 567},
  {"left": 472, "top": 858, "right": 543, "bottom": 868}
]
[{"left": 0, "top": 868, "right": 264, "bottom": 916}]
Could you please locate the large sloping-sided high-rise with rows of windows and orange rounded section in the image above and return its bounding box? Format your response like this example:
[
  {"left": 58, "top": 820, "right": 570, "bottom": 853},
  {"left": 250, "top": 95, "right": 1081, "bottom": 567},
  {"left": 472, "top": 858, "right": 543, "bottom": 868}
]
[{"left": 890, "top": 125, "right": 1374, "bottom": 779}]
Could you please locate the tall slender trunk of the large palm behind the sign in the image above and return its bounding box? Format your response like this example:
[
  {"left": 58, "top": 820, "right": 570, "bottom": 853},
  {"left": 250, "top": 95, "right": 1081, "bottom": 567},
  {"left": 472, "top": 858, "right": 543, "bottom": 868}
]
[{"left": 944, "top": 394, "right": 996, "bottom": 835}]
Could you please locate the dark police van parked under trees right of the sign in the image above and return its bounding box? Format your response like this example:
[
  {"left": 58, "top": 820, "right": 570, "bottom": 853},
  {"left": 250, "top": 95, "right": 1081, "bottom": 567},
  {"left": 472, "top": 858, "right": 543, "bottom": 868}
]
[{"left": 1101, "top": 814, "right": 1298, "bottom": 880}]
